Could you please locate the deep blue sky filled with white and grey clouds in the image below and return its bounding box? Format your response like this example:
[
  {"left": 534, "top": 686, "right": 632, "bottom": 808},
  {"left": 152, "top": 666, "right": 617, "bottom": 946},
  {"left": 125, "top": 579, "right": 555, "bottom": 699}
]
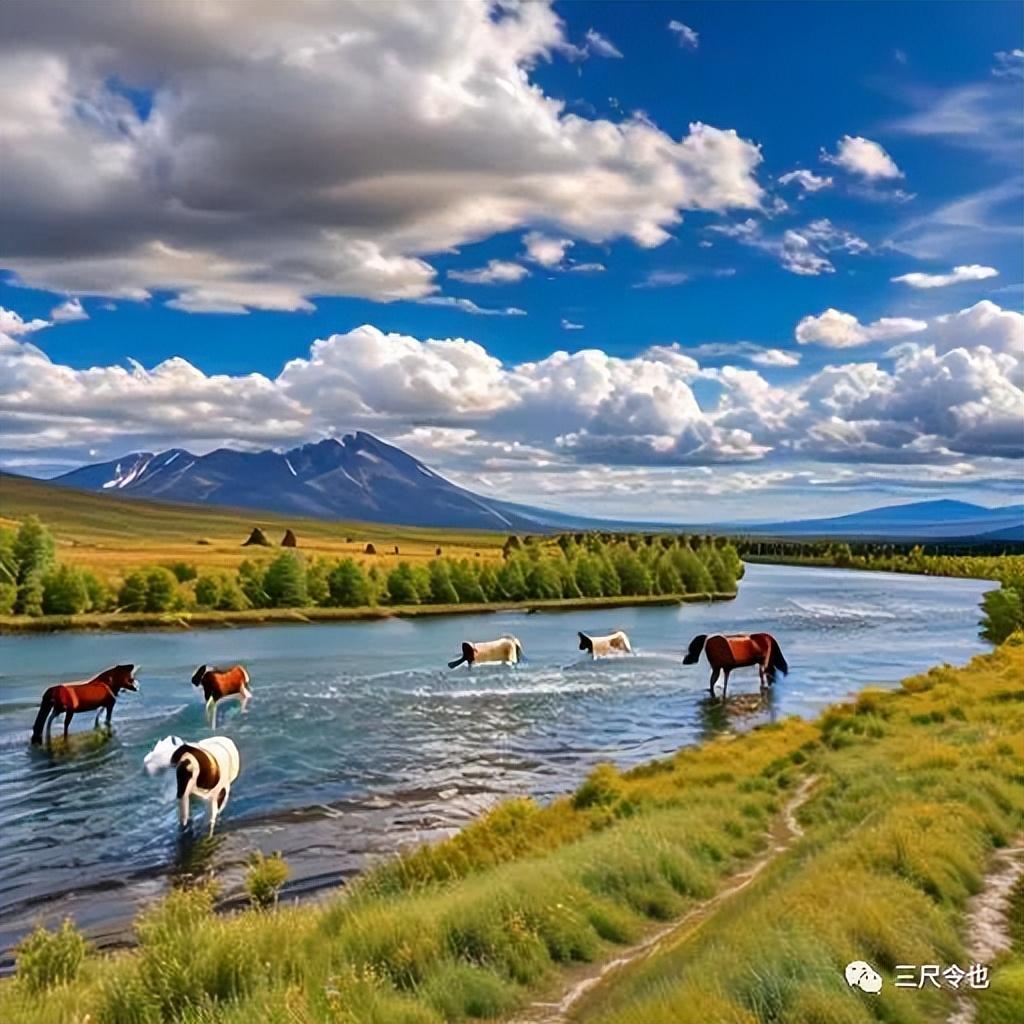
[{"left": 0, "top": 0, "right": 1024, "bottom": 522}]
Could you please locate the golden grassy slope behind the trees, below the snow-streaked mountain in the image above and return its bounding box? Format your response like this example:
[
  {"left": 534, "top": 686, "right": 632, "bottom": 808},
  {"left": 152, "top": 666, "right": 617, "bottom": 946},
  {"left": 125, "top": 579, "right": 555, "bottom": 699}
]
[{"left": 0, "top": 468, "right": 506, "bottom": 577}]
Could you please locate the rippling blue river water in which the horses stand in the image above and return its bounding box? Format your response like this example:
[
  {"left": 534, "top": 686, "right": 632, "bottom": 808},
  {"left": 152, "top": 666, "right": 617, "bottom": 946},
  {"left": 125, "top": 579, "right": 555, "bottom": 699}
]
[{"left": 0, "top": 565, "right": 991, "bottom": 950}]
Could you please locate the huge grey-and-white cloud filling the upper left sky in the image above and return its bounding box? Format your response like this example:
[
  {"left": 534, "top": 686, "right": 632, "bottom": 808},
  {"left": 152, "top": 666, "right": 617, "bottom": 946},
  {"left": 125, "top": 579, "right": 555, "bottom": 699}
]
[{"left": 0, "top": 0, "right": 762, "bottom": 312}]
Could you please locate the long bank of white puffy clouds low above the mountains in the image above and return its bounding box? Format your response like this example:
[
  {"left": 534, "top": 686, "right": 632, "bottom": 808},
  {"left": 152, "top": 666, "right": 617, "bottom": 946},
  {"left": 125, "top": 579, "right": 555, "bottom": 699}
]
[{"left": 0, "top": 302, "right": 1024, "bottom": 471}]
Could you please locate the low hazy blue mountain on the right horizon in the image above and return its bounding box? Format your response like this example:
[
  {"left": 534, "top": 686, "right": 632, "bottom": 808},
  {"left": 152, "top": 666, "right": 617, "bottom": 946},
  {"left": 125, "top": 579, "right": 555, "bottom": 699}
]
[{"left": 743, "top": 500, "right": 1024, "bottom": 541}]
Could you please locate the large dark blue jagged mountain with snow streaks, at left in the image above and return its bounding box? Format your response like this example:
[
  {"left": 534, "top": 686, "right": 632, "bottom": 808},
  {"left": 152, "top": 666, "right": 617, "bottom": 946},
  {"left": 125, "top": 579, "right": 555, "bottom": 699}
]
[{"left": 51, "top": 431, "right": 573, "bottom": 531}]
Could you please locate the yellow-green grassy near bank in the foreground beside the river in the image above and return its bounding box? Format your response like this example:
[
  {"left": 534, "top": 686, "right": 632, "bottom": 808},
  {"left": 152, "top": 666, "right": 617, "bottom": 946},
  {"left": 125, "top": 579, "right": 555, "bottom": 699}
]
[{"left": 0, "top": 634, "right": 1024, "bottom": 1024}]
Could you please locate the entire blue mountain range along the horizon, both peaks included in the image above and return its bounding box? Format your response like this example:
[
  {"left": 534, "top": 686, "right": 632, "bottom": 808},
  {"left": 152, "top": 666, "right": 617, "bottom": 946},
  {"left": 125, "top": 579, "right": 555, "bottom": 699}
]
[{"left": 51, "top": 431, "right": 1024, "bottom": 542}]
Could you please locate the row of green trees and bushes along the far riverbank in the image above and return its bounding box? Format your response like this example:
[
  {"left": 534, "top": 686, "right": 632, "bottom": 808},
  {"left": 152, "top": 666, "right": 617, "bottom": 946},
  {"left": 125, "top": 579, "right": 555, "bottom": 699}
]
[{"left": 0, "top": 516, "right": 743, "bottom": 615}]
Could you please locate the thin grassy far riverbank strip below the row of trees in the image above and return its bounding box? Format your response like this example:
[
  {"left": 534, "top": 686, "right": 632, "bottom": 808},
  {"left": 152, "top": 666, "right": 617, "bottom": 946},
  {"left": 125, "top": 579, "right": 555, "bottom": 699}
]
[{"left": 0, "top": 592, "right": 736, "bottom": 636}]
